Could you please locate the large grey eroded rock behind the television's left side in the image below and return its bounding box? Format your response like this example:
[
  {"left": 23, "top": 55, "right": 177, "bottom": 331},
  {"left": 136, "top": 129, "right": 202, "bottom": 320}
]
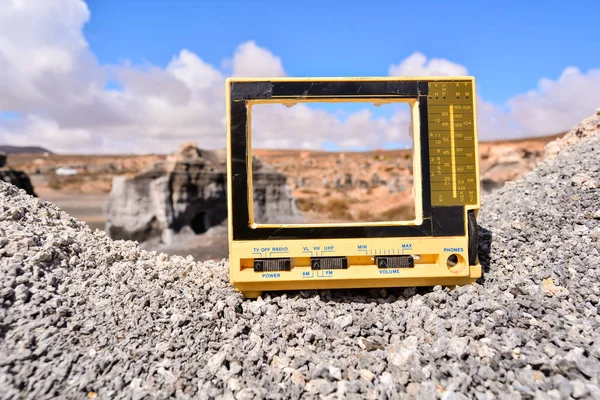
[{"left": 106, "top": 142, "right": 301, "bottom": 244}]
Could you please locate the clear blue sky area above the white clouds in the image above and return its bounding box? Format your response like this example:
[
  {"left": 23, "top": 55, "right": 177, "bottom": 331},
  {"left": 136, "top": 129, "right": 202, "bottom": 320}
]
[{"left": 84, "top": 0, "right": 600, "bottom": 103}]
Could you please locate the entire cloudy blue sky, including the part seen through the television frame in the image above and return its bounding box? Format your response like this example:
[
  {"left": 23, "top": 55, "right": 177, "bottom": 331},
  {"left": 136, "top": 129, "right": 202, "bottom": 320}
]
[{"left": 0, "top": 0, "right": 600, "bottom": 153}]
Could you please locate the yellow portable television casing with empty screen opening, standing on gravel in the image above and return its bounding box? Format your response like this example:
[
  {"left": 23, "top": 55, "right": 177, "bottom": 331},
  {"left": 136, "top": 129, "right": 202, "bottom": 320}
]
[{"left": 226, "top": 76, "right": 481, "bottom": 298}]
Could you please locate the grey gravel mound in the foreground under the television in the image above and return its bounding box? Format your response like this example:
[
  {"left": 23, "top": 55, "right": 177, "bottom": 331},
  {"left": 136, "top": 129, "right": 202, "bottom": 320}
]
[{"left": 0, "top": 132, "right": 600, "bottom": 399}]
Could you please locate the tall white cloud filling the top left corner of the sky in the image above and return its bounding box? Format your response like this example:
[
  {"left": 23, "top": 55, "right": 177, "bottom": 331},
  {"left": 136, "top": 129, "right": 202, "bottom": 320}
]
[{"left": 0, "top": 0, "right": 102, "bottom": 112}]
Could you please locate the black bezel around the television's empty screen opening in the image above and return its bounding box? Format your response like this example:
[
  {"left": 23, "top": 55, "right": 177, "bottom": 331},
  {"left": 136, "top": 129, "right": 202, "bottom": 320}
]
[{"left": 228, "top": 80, "right": 465, "bottom": 240}]
